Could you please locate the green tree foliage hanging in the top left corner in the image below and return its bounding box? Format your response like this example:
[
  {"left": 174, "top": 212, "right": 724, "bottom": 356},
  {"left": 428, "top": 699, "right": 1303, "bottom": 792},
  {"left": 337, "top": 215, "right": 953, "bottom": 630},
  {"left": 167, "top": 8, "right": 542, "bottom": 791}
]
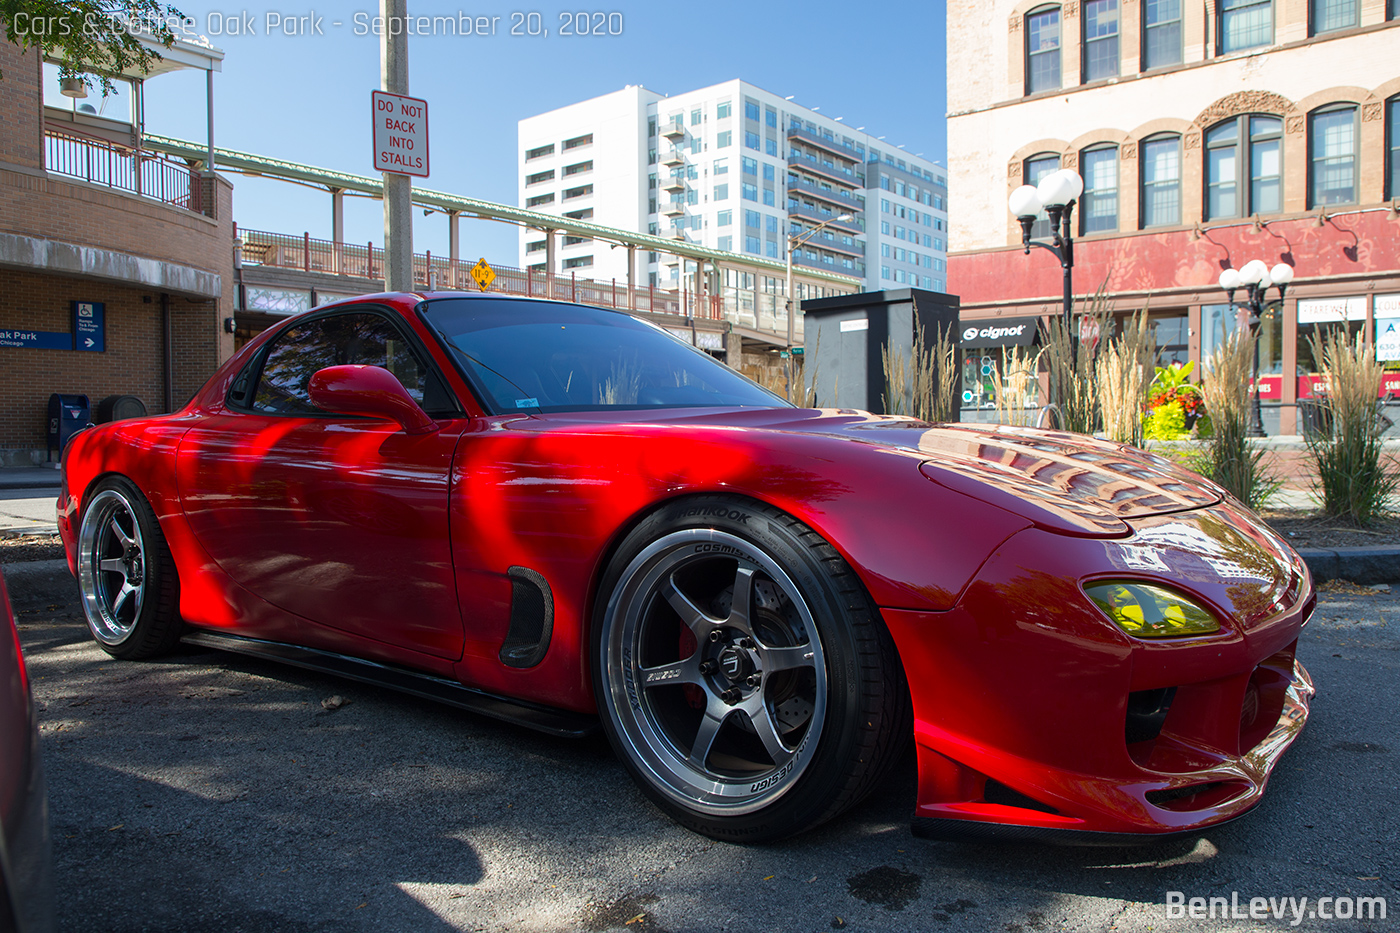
[{"left": 0, "top": 0, "right": 185, "bottom": 97}]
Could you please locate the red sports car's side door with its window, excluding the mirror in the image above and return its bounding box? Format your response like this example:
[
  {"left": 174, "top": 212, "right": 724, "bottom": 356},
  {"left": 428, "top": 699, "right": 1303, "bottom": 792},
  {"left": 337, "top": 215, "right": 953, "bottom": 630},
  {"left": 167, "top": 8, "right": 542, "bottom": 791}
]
[{"left": 179, "top": 307, "right": 463, "bottom": 658}]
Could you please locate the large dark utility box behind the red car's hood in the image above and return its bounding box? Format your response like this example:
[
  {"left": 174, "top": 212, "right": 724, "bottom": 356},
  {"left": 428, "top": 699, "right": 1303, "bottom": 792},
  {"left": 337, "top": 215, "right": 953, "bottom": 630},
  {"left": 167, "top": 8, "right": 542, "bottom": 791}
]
[{"left": 802, "top": 282, "right": 962, "bottom": 420}]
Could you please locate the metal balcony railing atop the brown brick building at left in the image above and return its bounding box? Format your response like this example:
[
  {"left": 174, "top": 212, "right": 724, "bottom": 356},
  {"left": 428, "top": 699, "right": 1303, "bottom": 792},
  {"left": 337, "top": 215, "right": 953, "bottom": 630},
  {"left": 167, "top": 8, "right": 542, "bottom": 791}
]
[{"left": 43, "top": 130, "right": 206, "bottom": 214}]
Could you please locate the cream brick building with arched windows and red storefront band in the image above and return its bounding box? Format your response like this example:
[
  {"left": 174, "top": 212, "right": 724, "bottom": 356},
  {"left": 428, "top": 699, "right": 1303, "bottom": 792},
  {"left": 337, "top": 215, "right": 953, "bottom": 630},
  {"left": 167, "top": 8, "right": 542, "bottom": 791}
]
[{"left": 948, "top": 0, "right": 1400, "bottom": 434}]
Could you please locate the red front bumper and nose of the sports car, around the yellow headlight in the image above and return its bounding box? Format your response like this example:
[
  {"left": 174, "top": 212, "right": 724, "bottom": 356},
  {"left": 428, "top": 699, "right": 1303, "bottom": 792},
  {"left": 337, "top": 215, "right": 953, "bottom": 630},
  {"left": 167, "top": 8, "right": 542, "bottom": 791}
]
[{"left": 883, "top": 504, "right": 1315, "bottom": 845}]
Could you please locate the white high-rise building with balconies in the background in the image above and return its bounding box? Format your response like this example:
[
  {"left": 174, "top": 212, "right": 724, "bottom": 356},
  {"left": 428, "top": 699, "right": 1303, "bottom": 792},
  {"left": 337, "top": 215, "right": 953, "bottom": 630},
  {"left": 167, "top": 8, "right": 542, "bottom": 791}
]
[{"left": 519, "top": 80, "right": 948, "bottom": 291}]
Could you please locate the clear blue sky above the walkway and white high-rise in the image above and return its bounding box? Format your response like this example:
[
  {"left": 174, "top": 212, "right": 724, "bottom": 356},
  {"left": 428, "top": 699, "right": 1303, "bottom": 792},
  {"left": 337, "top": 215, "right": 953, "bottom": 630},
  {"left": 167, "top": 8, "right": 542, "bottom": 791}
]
[{"left": 146, "top": 0, "right": 946, "bottom": 265}]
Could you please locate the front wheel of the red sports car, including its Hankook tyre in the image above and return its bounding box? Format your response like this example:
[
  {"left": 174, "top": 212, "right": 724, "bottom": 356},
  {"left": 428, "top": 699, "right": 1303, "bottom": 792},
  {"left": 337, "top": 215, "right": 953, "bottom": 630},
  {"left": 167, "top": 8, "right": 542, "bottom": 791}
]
[{"left": 594, "top": 497, "right": 909, "bottom": 842}]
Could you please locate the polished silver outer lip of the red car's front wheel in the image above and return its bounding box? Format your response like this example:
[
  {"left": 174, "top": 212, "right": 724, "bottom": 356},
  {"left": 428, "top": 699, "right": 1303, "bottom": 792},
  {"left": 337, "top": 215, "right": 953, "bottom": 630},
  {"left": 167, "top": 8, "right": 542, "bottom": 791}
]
[{"left": 602, "top": 528, "right": 827, "bottom": 817}]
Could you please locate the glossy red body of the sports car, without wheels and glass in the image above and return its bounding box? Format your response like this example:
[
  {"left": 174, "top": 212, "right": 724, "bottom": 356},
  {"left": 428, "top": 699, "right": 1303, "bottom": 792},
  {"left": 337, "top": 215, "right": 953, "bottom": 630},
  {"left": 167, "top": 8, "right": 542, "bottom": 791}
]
[{"left": 59, "top": 296, "right": 1315, "bottom": 841}]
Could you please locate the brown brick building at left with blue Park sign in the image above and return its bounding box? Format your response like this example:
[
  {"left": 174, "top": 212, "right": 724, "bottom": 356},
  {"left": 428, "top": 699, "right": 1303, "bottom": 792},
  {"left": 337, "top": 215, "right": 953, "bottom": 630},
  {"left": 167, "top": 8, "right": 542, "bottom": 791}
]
[{"left": 0, "top": 34, "right": 234, "bottom": 464}]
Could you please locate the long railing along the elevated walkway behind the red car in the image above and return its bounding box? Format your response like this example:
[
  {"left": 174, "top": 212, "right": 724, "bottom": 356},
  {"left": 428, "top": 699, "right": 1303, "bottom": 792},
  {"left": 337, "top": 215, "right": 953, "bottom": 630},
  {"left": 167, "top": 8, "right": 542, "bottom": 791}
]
[{"left": 235, "top": 227, "right": 802, "bottom": 335}]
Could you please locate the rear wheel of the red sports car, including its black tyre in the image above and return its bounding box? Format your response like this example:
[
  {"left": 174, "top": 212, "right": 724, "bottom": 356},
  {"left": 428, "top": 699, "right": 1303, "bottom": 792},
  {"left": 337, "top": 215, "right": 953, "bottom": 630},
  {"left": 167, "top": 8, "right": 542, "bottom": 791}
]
[{"left": 77, "top": 476, "right": 182, "bottom": 660}]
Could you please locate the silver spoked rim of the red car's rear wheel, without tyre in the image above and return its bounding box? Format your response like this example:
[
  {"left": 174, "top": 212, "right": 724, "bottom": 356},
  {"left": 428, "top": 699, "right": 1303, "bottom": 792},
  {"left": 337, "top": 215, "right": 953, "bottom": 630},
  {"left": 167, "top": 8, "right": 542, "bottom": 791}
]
[{"left": 77, "top": 489, "right": 148, "bottom": 644}]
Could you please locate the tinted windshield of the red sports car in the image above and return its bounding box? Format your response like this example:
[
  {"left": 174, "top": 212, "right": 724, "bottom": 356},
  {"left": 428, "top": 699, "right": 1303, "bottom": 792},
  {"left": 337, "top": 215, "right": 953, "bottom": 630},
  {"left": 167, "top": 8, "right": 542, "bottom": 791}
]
[{"left": 423, "top": 298, "right": 788, "bottom": 413}]
